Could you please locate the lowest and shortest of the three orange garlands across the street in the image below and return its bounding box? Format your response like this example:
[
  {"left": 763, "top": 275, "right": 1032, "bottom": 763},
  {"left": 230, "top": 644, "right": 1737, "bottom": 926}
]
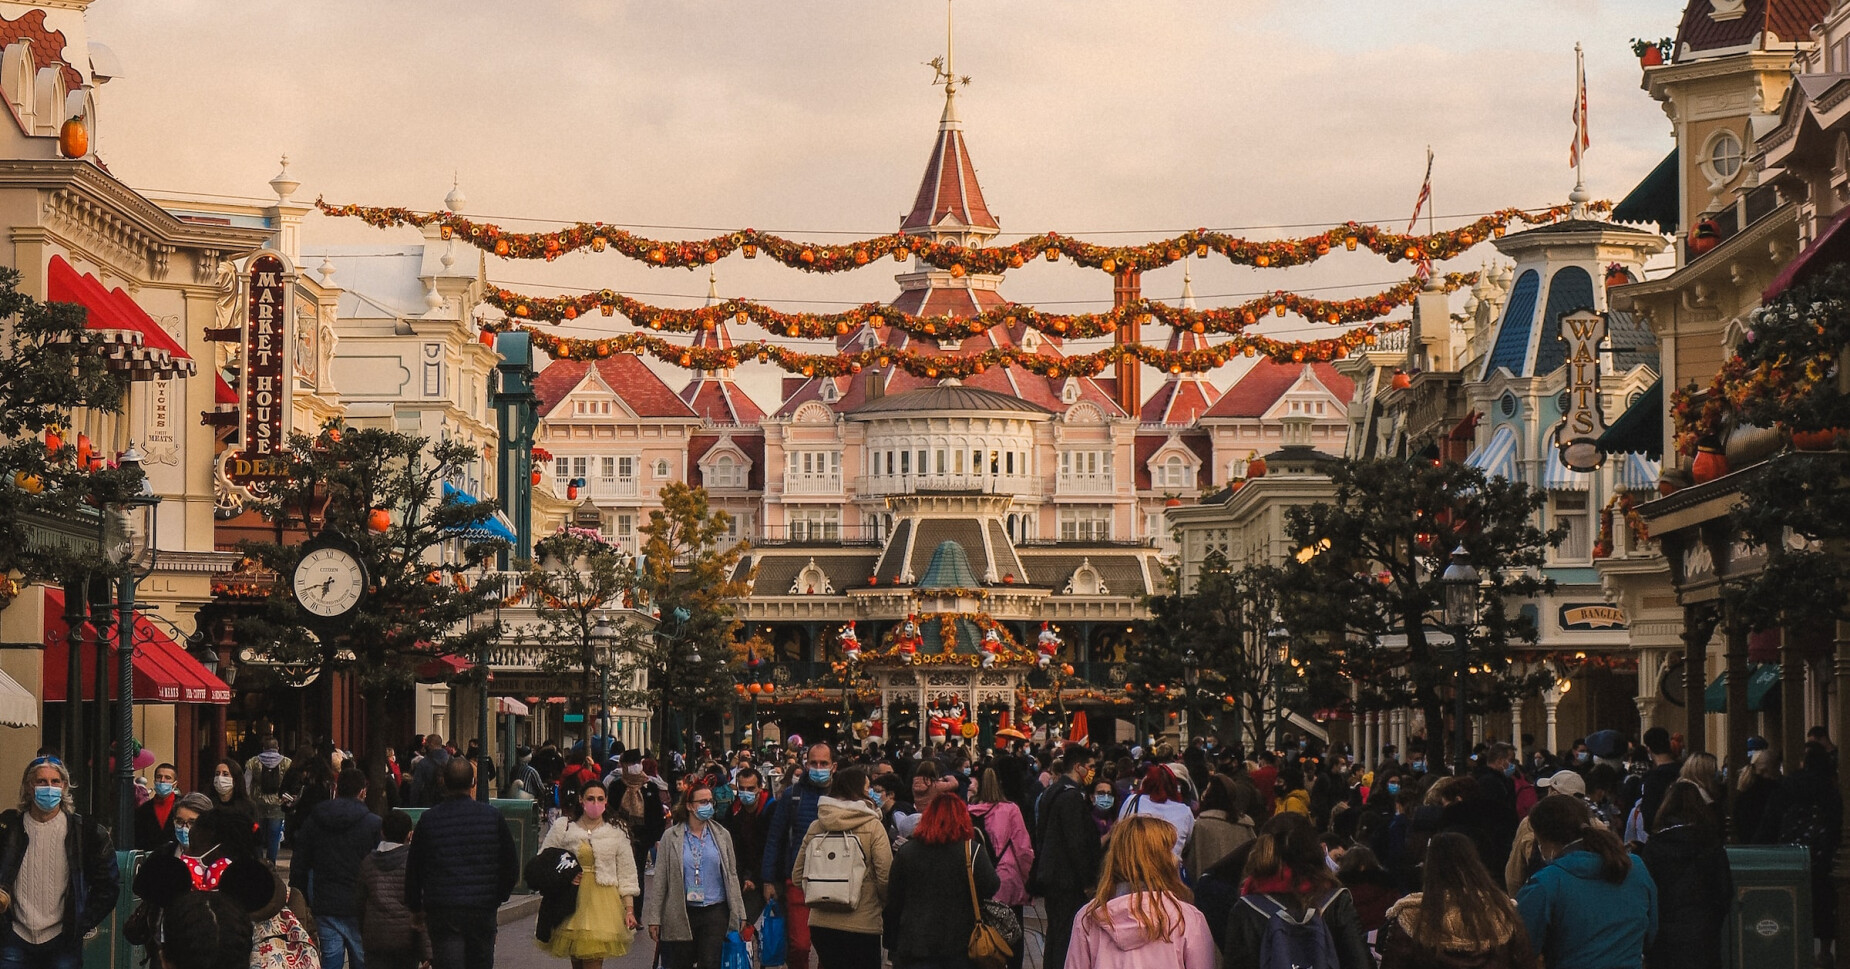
[{"left": 483, "top": 320, "right": 1406, "bottom": 379}]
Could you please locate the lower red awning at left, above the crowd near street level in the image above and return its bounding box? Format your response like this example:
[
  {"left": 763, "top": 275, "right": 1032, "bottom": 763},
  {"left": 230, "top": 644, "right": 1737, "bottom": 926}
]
[{"left": 44, "top": 588, "right": 231, "bottom": 703}]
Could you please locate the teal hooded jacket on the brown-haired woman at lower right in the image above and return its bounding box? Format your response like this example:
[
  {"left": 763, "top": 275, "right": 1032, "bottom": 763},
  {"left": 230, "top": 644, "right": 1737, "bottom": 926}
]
[{"left": 1515, "top": 851, "right": 1658, "bottom": 969}]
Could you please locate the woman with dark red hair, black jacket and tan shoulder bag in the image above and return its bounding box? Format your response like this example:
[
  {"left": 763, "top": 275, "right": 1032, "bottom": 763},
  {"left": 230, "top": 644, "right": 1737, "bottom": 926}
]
[{"left": 886, "top": 793, "right": 1003, "bottom": 969}]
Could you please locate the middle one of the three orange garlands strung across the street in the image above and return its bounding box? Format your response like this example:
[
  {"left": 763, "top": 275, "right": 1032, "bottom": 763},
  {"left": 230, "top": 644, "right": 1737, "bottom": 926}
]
[{"left": 483, "top": 272, "right": 1478, "bottom": 340}]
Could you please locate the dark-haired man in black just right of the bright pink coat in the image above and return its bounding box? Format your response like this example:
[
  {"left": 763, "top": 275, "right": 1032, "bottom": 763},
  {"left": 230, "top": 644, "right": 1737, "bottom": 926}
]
[{"left": 1029, "top": 743, "right": 1104, "bottom": 965}]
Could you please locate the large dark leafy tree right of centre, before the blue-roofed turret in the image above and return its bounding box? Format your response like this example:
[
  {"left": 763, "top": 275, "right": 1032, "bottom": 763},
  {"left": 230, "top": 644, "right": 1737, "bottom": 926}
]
[{"left": 1280, "top": 459, "right": 1565, "bottom": 769}]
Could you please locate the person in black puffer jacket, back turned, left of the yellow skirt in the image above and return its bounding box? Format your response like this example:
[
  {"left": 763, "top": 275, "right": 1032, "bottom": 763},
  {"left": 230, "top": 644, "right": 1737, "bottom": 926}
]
[{"left": 405, "top": 756, "right": 520, "bottom": 969}]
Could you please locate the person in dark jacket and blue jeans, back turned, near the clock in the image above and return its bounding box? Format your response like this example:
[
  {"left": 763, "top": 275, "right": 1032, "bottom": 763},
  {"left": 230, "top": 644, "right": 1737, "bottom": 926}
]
[{"left": 289, "top": 767, "right": 379, "bottom": 969}]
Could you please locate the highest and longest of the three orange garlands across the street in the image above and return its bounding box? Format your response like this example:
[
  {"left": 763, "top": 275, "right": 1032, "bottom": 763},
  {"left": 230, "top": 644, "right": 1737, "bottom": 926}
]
[{"left": 315, "top": 198, "right": 1611, "bottom": 276}]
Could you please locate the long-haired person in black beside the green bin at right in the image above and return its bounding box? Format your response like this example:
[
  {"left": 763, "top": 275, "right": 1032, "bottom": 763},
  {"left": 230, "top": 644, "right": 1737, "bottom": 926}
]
[{"left": 1639, "top": 780, "right": 1733, "bottom": 969}]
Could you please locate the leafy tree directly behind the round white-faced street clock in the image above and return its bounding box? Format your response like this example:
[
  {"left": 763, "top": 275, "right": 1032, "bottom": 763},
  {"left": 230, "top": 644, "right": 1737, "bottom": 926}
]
[{"left": 244, "top": 425, "right": 505, "bottom": 791}]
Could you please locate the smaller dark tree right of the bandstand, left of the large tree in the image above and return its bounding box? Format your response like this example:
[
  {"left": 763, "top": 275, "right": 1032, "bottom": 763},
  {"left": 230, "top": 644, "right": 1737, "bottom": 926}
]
[{"left": 1127, "top": 551, "right": 1310, "bottom": 745}]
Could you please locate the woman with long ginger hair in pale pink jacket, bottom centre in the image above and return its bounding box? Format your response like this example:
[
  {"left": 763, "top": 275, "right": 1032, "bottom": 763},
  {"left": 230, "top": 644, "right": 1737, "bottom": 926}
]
[{"left": 1066, "top": 814, "right": 1215, "bottom": 969}]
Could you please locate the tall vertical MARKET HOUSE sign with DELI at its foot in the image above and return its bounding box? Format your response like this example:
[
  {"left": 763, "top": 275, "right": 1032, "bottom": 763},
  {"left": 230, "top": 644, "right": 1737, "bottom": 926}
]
[{"left": 226, "top": 253, "right": 289, "bottom": 490}]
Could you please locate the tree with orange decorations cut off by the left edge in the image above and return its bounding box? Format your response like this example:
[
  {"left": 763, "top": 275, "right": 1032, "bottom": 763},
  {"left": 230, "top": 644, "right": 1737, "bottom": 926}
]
[{"left": 0, "top": 266, "right": 141, "bottom": 584}]
